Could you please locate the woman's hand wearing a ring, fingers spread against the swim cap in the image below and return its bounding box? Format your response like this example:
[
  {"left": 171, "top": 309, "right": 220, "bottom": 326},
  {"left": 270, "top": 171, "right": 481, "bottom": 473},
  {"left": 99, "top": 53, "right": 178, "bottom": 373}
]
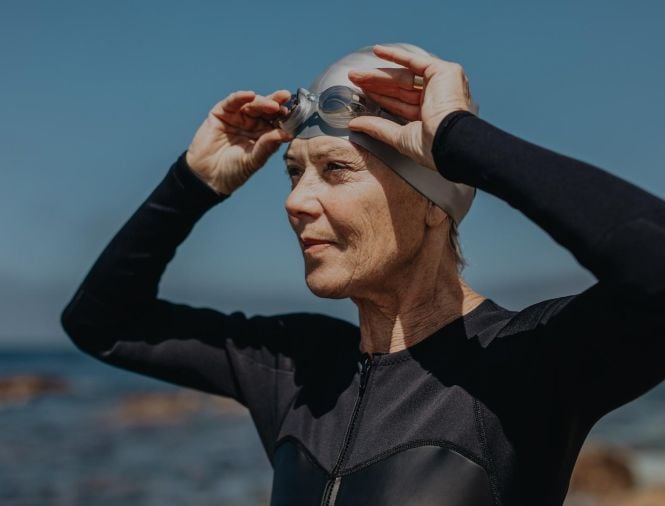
[{"left": 349, "top": 45, "right": 477, "bottom": 170}]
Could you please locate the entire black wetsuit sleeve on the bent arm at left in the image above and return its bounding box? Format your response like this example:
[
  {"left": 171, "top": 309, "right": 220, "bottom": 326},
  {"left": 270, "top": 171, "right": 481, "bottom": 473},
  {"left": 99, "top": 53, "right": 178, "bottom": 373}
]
[{"left": 61, "top": 153, "right": 351, "bottom": 456}]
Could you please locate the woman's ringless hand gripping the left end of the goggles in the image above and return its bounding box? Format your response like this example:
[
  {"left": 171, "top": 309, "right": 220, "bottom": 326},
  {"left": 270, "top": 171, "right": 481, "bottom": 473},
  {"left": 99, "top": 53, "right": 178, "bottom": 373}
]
[{"left": 186, "top": 90, "right": 291, "bottom": 195}]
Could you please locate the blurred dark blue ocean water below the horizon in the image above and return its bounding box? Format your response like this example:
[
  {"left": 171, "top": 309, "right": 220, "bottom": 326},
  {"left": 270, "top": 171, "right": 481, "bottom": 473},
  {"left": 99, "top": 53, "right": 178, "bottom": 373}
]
[{"left": 0, "top": 349, "right": 665, "bottom": 506}]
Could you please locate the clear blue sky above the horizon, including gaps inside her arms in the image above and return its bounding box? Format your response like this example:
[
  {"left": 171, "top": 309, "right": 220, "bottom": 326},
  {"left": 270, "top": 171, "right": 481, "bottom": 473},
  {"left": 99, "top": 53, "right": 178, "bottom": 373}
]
[{"left": 0, "top": 0, "right": 665, "bottom": 346}]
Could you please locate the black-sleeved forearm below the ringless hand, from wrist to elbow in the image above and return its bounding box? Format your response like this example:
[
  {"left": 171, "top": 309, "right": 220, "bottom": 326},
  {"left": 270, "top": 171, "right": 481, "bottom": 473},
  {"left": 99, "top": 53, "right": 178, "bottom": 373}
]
[{"left": 63, "top": 153, "right": 226, "bottom": 320}]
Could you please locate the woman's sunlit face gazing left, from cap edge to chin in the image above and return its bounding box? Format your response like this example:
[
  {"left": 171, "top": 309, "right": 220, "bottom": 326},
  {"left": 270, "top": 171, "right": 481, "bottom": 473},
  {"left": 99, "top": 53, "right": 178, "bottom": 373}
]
[{"left": 284, "top": 136, "right": 428, "bottom": 298}]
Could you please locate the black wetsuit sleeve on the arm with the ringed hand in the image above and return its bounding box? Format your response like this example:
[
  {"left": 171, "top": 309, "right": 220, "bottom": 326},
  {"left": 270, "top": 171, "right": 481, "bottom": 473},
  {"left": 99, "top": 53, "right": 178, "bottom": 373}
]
[{"left": 432, "top": 111, "right": 665, "bottom": 417}]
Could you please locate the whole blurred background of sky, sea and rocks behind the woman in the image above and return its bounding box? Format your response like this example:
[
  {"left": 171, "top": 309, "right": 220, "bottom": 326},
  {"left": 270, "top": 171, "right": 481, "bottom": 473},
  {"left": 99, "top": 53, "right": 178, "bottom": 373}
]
[{"left": 0, "top": 0, "right": 665, "bottom": 506}]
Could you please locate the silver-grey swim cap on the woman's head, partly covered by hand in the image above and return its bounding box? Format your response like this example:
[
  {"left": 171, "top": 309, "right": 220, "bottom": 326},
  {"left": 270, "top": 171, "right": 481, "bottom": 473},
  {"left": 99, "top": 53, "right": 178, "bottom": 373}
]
[{"left": 288, "top": 43, "right": 476, "bottom": 224}]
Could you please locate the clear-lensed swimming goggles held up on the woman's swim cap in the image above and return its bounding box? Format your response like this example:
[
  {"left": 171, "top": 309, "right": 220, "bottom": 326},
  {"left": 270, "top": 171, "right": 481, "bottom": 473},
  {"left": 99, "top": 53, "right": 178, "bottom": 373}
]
[{"left": 273, "top": 85, "right": 405, "bottom": 135}]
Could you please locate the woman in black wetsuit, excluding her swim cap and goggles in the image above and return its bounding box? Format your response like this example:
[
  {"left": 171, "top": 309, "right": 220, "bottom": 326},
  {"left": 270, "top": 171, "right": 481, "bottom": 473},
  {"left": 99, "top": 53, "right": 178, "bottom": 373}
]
[{"left": 62, "top": 46, "right": 665, "bottom": 506}]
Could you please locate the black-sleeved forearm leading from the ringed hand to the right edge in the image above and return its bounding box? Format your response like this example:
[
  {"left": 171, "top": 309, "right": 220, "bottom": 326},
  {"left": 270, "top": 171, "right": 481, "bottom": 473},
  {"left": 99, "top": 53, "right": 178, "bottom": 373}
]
[{"left": 432, "top": 113, "right": 665, "bottom": 295}]
